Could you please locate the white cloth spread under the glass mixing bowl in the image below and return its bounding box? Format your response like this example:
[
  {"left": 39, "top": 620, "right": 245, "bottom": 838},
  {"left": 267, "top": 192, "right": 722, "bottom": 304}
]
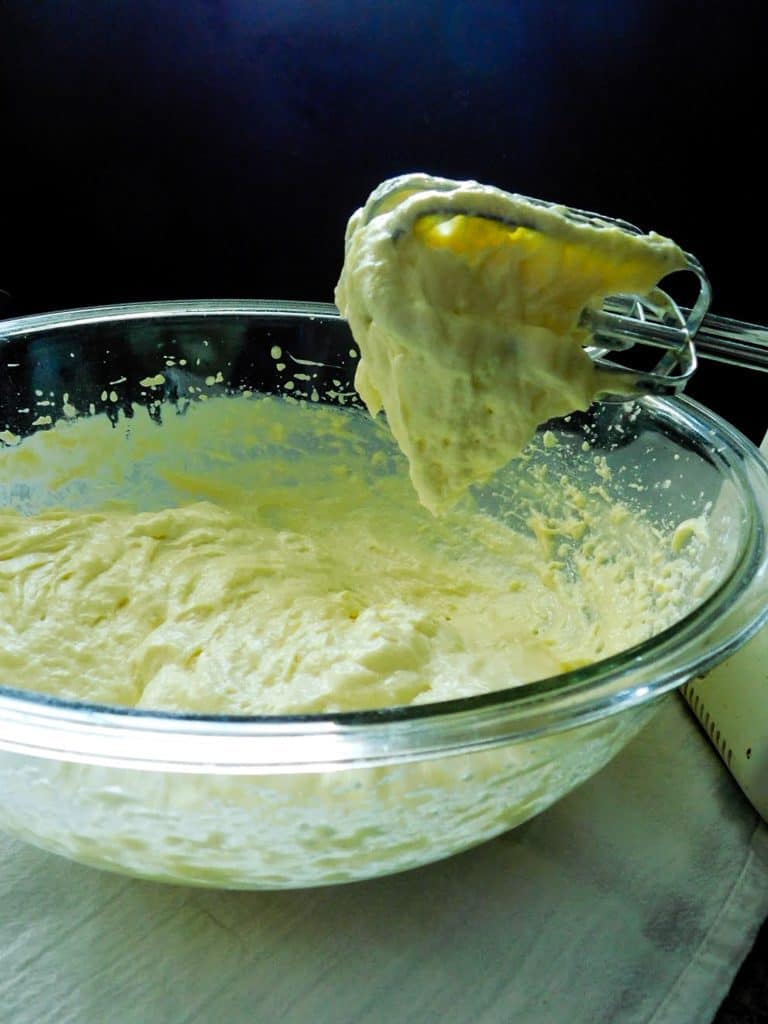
[{"left": 0, "top": 697, "right": 768, "bottom": 1024}]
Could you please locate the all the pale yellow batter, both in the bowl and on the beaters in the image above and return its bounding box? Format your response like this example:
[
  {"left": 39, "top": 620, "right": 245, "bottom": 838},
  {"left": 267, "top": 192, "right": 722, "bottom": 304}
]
[{"left": 0, "top": 175, "right": 707, "bottom": 715}]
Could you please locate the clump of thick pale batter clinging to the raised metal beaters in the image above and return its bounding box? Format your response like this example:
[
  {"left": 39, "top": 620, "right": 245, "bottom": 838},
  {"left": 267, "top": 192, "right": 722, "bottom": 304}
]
[{"left": 336, "top": 174, "right": 686, "bottom": 512}]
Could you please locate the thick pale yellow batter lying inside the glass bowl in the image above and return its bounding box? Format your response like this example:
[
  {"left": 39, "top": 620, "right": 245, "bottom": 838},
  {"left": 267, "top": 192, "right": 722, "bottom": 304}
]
[{"left": 0, "top": 397, "right": 703, "bottom": 714}]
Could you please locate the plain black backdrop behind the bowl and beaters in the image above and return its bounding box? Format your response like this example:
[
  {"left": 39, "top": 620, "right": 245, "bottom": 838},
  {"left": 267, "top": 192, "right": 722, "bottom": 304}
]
[{"left": 0, "top": 0, "right": 768, "bottom": 438}]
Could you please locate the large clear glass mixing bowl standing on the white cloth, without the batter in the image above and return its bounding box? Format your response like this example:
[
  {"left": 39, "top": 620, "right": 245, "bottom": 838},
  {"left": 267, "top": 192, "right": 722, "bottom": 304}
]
[{"left": 0, "top": 301, "right": 768, "bottom": 889}]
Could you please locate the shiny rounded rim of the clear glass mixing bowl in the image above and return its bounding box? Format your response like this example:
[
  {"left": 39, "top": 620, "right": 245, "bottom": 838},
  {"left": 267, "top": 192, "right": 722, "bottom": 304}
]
[{"left": 0, "top": 299, "right": 768, "bottom": 774}]
